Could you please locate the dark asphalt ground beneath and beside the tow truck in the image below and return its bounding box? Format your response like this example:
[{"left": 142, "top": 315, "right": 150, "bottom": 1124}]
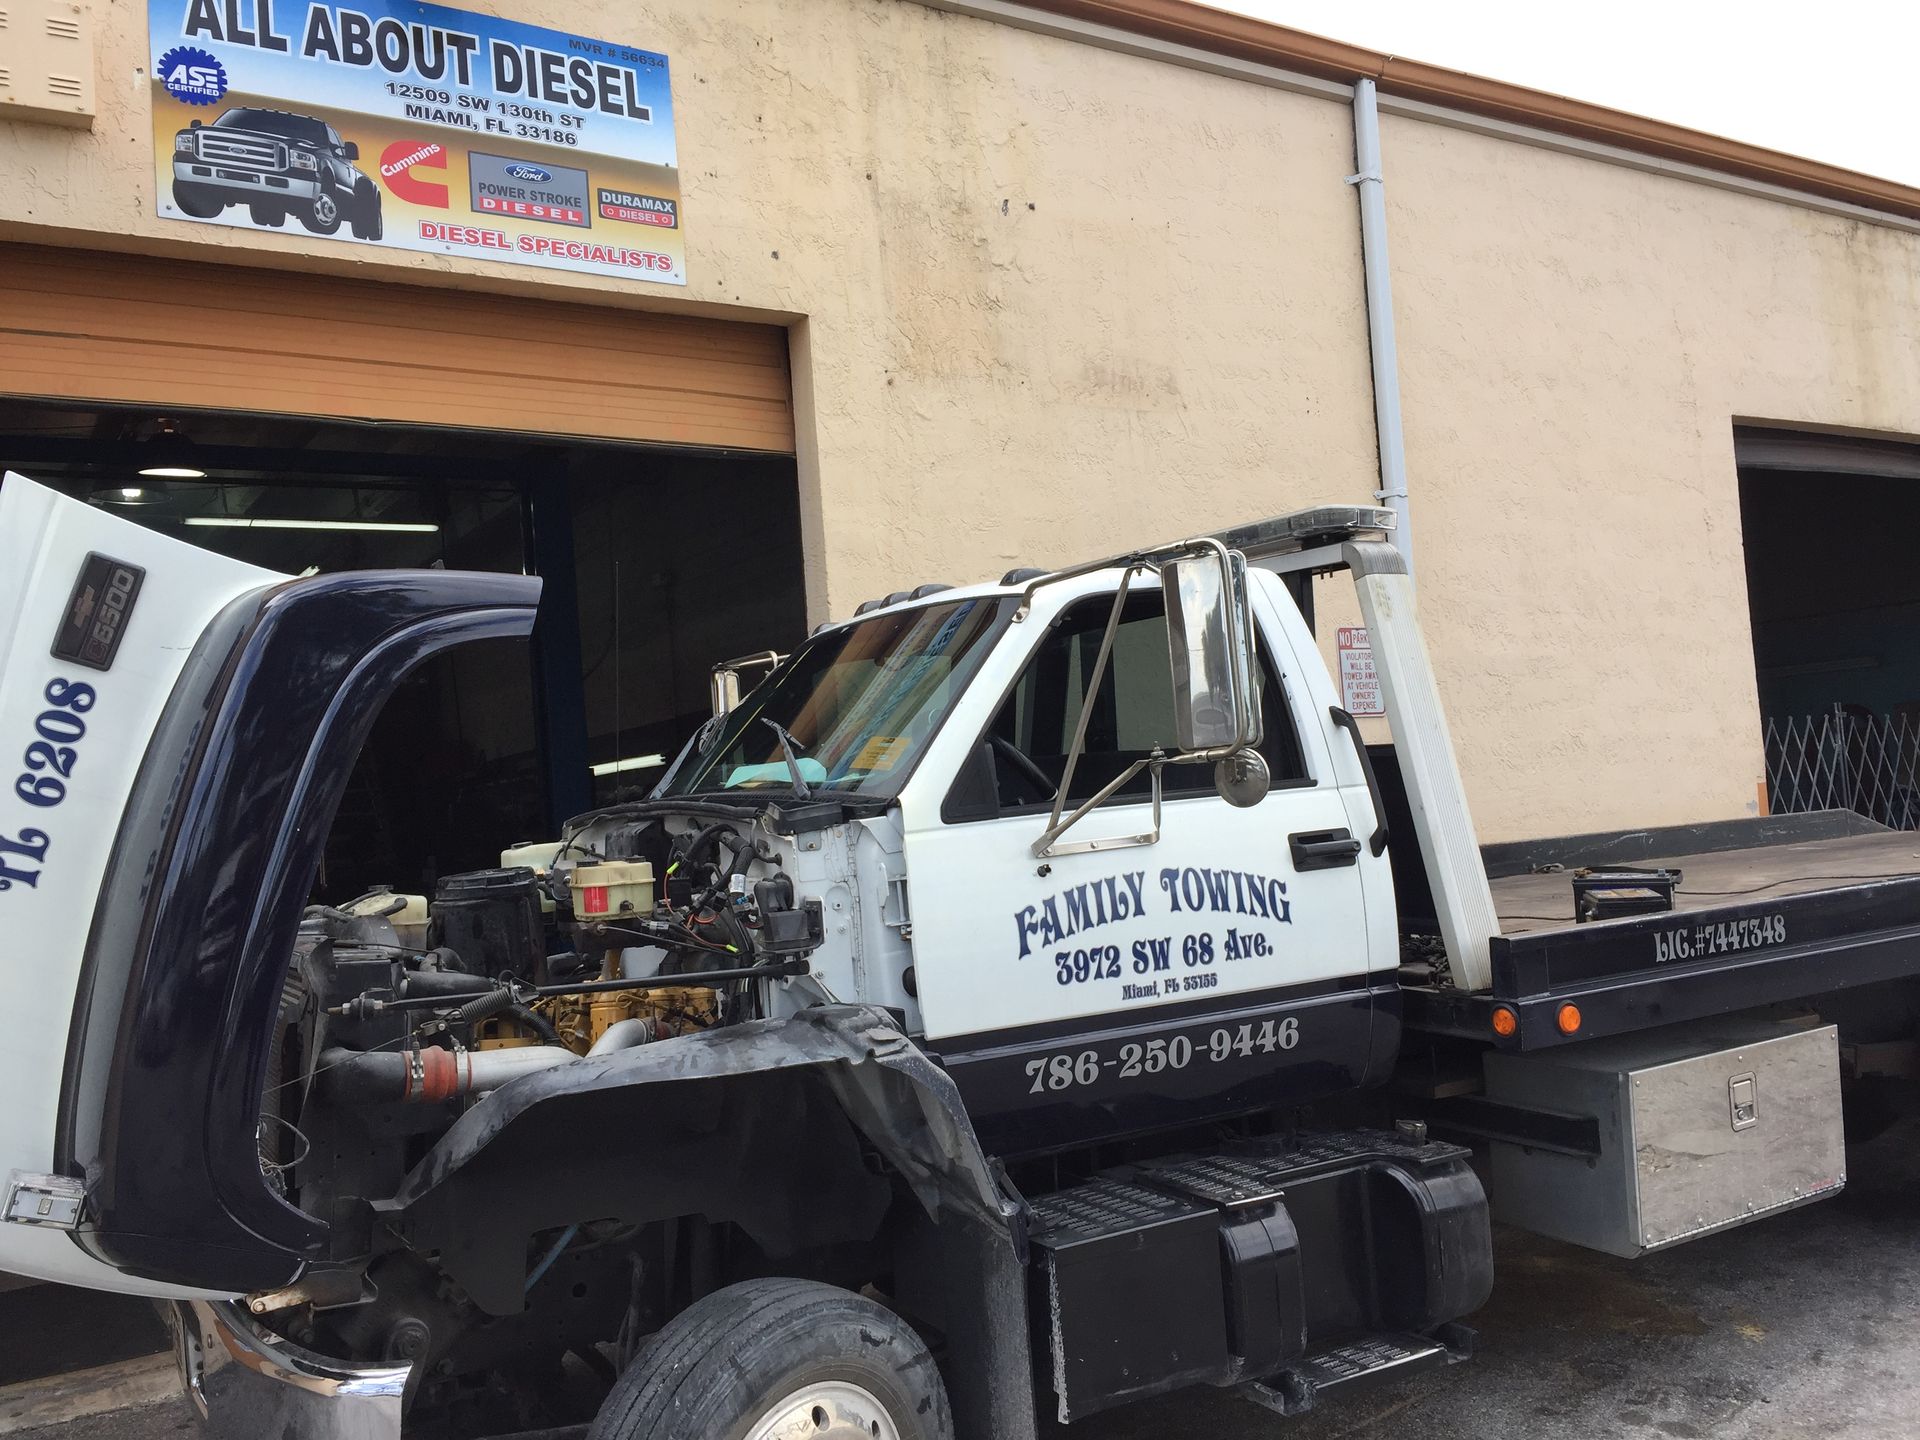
[{"left": 15, "top": 1123, "right": 1920, "bottom": 1440}]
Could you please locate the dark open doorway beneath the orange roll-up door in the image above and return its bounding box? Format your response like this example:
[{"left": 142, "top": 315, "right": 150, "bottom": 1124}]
[{"left": 0, "top": 396, "right": 806, "bottom": 902}]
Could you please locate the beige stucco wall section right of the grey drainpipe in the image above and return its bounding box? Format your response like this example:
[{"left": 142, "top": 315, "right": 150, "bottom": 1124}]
[{"left": 1384, "top": 117, "right": 1920, "bottom": 839}]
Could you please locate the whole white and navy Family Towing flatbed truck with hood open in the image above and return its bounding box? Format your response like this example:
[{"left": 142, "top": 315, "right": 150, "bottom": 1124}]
[{"left": 0, "top": 476, "right": 1920, "bottom": 1440}]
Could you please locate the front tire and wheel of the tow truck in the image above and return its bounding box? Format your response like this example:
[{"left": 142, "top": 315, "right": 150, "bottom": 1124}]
[{"left": 588, "top": 1281, "right": 954, "bottom": 1440}]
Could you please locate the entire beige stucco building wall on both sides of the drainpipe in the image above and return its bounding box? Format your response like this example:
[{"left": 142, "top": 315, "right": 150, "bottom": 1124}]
[{"left": 11, "top": 0, "right": 1920, "bottom": 839}]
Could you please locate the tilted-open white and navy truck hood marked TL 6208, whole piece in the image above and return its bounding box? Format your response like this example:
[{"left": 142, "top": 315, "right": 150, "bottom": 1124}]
[{"left": 0, "top": 474, "right": 540, "bottom": 1296}]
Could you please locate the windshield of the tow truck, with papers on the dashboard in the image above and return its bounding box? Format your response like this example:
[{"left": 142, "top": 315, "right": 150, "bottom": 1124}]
[{"left": 659, "top": 597, "right": 1002, "bottom": 797}]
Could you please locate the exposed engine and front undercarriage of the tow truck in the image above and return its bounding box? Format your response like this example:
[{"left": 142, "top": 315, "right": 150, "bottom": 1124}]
[{"left": 250, "top": 806, "right": 822, "bottom": 1428}]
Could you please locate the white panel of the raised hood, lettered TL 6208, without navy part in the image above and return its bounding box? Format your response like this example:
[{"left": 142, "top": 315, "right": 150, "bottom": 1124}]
[{"left": 0, "top": 474, "right": 282, "bottom": 1288}]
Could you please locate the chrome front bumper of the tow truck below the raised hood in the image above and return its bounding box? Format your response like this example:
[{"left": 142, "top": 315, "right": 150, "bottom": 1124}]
[{"left": 167, "top": 1300, "right": 411, "bottom": 1440}]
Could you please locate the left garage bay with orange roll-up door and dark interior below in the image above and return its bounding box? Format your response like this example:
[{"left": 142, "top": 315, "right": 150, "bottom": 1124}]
[{"left": 0, "top": 246, "right": 806, "bottom": 900}]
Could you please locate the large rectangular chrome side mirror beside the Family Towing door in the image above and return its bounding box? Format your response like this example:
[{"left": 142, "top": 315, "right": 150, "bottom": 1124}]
[{"left": 1160, "top": 545, "right": 1263, "bottom": 753}]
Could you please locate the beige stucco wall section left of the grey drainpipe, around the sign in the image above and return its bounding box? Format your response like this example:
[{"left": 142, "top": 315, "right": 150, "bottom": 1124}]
[{"left": 0, "top": 0, "right": 1375, "bottom": 602}]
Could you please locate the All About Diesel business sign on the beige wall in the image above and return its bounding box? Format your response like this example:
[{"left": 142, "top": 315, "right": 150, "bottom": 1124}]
[{"left": 148, "top": 0, "right": 687, "bottom": 284}]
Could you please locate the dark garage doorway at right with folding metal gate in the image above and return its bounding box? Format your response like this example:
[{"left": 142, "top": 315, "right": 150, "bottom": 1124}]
[{"left": 1736, "top": 428, "right": 1920, "bottom": 829}]
